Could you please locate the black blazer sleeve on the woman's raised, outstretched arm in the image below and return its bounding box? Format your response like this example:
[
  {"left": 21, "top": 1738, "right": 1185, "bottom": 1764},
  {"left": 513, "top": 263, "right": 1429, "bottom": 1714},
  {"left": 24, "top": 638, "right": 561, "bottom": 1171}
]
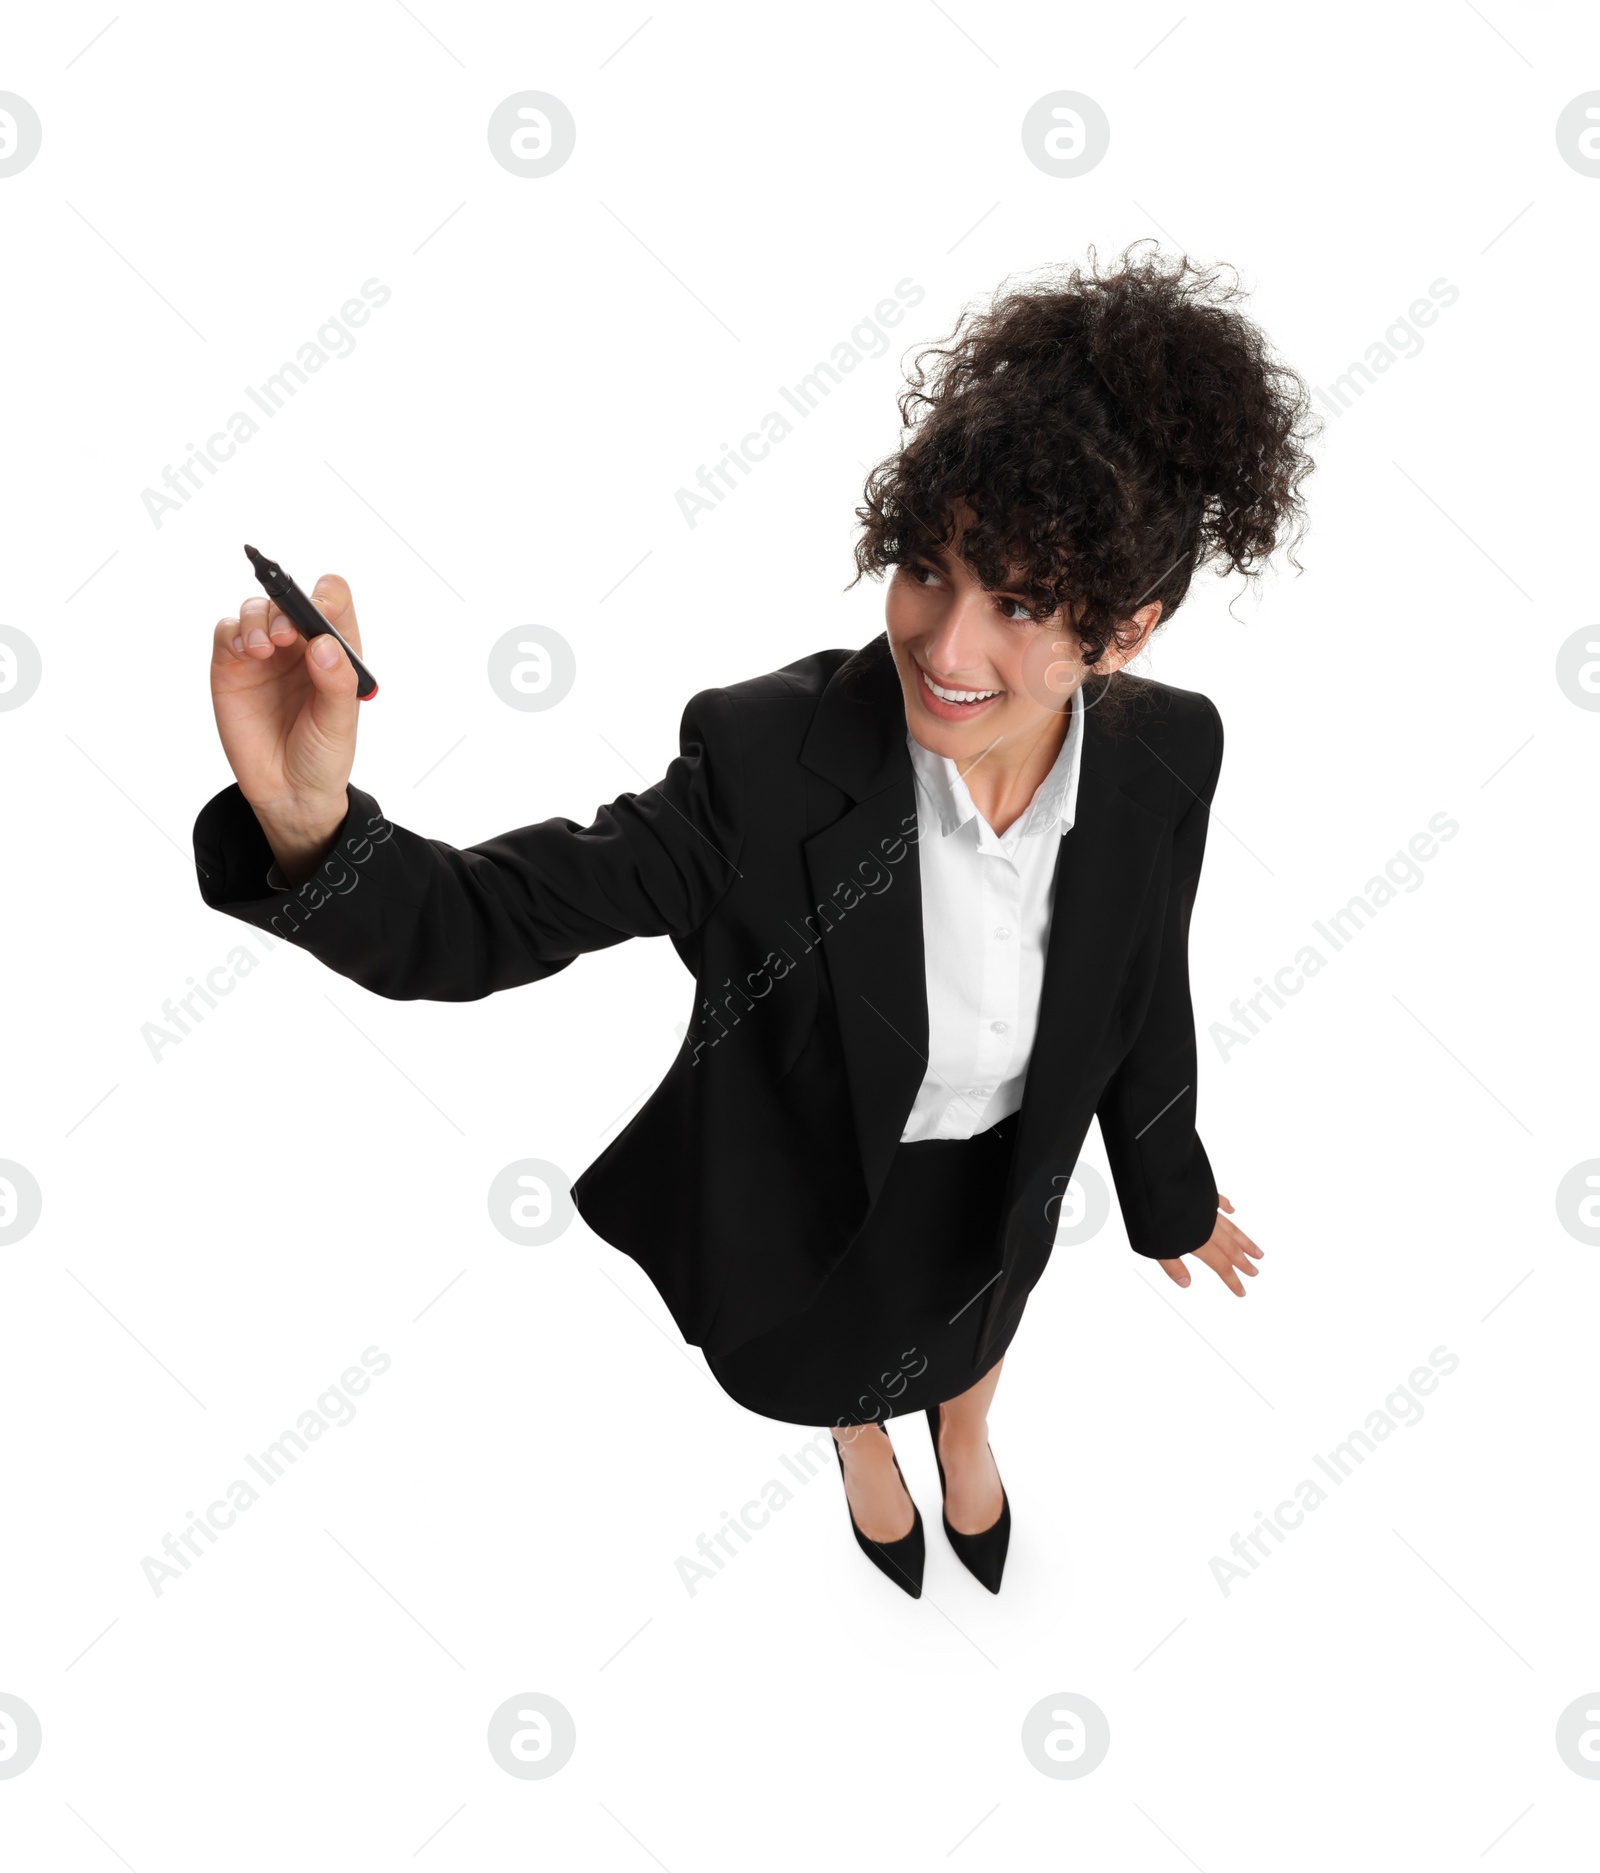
[{"left": 195, "top": 689, "right": 746, "bottom": 1002}]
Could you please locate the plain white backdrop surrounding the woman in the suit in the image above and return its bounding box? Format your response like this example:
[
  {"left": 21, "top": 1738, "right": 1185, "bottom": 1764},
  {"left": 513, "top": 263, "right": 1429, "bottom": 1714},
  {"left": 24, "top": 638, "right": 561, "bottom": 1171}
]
[{"left": 0, "top": 0, "right": 1600, "bottom": 1873}]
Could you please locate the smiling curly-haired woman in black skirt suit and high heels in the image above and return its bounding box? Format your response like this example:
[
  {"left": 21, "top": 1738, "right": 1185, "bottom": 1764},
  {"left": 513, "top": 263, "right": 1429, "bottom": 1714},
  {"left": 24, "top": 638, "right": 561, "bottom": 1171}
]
[{"left": 195, "top": 249, "right": 1315, "bottom": 1596}]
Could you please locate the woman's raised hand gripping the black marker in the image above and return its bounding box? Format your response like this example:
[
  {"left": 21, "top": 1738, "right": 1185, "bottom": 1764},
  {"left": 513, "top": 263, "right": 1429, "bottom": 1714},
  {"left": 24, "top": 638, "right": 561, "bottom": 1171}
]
[{"left": 212, "top": 573, "right": 362, "bottom": 882}]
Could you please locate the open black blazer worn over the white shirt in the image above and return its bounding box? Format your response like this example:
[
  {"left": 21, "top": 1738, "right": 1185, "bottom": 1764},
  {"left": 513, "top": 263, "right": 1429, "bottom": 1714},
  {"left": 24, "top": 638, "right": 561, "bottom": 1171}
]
[{"left": 195, "top": 635, "right": 1222, "bottom": 1365}]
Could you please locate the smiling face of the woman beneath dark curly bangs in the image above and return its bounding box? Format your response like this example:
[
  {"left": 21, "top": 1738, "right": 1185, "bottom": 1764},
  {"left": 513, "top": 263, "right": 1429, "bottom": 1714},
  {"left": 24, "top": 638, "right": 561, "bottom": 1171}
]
[{"left": 884, "top": 513, "right": 1162, "bottom": 762}]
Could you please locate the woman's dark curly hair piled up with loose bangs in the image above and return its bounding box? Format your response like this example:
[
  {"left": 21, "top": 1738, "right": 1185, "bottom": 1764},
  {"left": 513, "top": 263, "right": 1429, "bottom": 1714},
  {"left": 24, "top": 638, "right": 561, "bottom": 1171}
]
[{"left": 847, "top": 242, "right": 1321, "bottom": 704}]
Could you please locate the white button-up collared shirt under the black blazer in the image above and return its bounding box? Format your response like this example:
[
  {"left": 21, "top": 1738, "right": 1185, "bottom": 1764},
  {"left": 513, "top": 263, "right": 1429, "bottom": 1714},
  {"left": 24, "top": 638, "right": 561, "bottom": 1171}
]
[{"left": 899, "top": 693, "right": 1083, "bottom": 1144}]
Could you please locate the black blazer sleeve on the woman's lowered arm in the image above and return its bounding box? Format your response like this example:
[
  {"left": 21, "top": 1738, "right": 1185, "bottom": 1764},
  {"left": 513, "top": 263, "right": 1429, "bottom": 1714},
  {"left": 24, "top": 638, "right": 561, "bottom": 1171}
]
[{"left": 1096, "top": 699, "right": 1222, "bottom": 1261}]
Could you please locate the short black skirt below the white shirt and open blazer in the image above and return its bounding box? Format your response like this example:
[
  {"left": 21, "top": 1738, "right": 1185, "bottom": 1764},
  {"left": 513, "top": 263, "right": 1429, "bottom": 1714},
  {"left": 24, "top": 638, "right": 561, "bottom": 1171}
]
[{"left": 706, "top": 1113, "right": 1021, "bottom": 1425}]
